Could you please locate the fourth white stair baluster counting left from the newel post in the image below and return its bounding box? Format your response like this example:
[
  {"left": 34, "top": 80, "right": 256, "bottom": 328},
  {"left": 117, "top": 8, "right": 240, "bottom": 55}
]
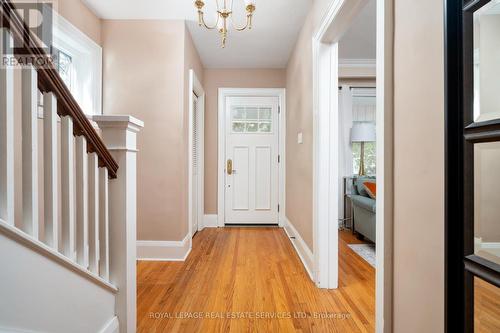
[{"left": 61, "top": 116, "right": 76, "bottom": 260}]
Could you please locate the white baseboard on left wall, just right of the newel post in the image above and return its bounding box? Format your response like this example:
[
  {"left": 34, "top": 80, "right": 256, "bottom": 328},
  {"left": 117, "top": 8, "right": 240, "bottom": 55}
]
[{"left": 137, "top": 234, "right": 191, "bottom": 261}]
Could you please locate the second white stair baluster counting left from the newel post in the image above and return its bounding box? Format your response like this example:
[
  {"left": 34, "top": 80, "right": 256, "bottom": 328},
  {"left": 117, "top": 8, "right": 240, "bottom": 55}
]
[{"left": 89, "top": 153, "right": 99, "bottom": 274}]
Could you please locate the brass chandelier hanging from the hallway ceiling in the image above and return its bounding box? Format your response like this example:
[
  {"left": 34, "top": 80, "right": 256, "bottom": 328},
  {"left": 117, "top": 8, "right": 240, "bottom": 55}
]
[{"left": 194, "top": 0, "right": 255, "bottom": 48}]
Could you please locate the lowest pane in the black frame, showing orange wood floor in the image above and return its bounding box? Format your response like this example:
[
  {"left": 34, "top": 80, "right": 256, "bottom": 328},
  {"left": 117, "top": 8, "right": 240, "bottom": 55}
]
[{"left": 474, "top": 277, "right": 500, "bottom": 333}]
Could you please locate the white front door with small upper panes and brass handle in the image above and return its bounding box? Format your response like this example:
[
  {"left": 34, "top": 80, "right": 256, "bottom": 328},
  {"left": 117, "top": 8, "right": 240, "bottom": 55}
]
[{"left": 224, "top": 97, "right": 279, "bottom": 224}]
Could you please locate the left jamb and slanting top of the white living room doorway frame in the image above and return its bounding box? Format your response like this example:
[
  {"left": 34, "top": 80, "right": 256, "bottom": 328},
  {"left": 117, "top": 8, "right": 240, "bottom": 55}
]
[{"left": 312, "top": 0, "right": 368, "bottom": 289}]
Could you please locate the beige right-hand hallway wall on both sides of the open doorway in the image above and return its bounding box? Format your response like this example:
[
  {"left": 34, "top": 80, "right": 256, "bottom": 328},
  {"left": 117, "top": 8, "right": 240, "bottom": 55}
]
[{"left": 286, "top": 0, "right": 444, "bottom": 333}]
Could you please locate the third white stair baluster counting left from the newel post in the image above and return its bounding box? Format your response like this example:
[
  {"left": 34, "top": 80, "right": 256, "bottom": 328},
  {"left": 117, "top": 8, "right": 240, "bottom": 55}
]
[{"left": 75, "top": 136, "right": 89, "bottom": 268}]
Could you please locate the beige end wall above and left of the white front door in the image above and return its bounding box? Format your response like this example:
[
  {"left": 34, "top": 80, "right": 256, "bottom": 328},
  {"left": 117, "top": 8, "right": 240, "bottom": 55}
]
[{"left": 203, "top": 69, "right": 285, "bottom": 214}]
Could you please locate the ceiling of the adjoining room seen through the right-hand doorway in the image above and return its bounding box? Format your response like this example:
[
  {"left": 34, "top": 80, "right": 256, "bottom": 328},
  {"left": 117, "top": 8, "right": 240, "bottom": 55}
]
[{"left": 339, "top": 0, "right": 377, "bottom": 60}]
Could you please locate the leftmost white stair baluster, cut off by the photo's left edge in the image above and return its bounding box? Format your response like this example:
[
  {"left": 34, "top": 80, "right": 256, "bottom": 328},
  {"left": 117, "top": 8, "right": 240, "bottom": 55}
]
[{"left": 0, "top": 28, "right": 14, "bottom": 225}]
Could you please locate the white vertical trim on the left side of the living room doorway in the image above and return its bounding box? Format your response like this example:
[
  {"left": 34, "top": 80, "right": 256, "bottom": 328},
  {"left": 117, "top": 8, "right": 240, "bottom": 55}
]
[{"left": 313, "top": 39, "right": 340, "bottom": 288}]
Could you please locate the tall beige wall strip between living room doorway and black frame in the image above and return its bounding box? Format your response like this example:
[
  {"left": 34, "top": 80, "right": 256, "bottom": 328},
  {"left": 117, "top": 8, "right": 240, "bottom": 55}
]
[{"left": 393, "top": 0, "right": 444, "bottom": 333}]
